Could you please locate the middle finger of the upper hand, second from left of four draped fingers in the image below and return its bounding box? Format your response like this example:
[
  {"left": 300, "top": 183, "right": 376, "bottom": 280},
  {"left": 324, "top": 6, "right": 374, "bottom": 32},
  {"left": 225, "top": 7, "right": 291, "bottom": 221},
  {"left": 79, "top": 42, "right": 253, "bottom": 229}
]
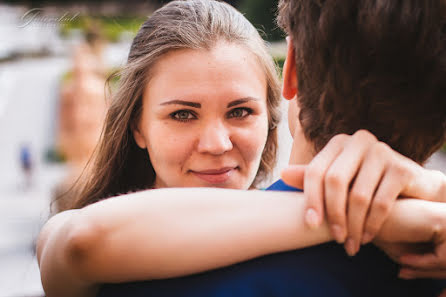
[{"left": 324, "top": 131, "right": 376, "bottom": 246}]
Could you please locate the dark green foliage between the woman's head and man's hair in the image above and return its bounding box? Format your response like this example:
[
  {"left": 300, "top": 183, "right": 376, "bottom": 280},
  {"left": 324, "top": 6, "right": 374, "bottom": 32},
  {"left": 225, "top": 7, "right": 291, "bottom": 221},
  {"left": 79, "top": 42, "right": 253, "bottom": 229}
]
[{"left": 238, "top": 0, "right": 284, "bottom": 41}]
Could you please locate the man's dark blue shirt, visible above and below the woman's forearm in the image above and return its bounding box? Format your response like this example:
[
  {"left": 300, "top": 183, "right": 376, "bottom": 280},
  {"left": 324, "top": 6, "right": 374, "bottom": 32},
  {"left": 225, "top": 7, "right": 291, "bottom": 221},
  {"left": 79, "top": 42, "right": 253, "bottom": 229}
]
[{"left": 98, "top": 180, "right": 446, "bottom": 297}]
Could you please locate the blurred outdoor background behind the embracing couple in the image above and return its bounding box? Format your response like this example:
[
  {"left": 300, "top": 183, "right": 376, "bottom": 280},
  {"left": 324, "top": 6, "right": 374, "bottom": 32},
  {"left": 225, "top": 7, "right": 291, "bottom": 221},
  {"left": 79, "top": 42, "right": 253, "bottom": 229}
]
[{"left": 0, "top": 0, "right": 446, "bottom": 297}]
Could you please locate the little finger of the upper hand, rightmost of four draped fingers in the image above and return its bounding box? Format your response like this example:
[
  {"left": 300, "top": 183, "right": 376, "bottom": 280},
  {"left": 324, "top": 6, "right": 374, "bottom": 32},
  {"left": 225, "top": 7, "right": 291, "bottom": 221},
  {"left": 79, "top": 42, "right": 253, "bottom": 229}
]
[{"left": 364, "top": 161, "right": 405, "bottom": 242}]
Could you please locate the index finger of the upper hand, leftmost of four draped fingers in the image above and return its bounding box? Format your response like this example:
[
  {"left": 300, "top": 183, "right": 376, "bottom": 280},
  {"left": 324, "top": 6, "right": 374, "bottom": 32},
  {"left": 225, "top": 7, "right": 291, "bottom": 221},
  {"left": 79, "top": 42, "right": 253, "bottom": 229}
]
[{"left": 304, "top": 134, "right": 349, "bottom": 228}]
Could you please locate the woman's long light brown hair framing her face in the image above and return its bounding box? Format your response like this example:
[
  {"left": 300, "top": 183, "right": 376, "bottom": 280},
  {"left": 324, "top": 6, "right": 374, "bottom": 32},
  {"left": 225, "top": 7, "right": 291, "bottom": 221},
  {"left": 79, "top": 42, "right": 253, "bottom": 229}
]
[{"left": 70, "top": 0, "right": 280, "bottom": 208}]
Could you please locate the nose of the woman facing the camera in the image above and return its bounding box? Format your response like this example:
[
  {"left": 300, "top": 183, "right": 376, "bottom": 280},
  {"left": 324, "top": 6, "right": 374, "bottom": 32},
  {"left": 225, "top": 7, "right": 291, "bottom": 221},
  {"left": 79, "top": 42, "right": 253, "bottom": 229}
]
[{"left": 197, "top": 123, "right": 233, "bottom": 155}]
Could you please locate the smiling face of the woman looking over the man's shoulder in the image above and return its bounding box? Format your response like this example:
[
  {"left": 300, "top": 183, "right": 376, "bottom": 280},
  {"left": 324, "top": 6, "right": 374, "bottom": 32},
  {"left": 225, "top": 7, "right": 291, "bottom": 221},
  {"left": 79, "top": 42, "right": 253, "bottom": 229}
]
[{"left": 134, "top": 42, "right": 268, "bottom": 189}]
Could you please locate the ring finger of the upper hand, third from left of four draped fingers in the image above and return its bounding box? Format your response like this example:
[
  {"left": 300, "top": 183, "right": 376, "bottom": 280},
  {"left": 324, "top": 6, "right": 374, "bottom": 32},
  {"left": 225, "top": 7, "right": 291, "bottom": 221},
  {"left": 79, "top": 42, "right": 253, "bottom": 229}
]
[{"left": 347, "top": 151, "right": 385, "bottom": 254}]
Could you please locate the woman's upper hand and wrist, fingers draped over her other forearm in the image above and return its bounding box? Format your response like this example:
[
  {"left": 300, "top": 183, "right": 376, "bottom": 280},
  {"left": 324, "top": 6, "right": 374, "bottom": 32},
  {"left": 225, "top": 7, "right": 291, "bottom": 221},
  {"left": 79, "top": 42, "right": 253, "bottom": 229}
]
[{"left": 282, "top": 130, "right": 446, "bottom": 255}]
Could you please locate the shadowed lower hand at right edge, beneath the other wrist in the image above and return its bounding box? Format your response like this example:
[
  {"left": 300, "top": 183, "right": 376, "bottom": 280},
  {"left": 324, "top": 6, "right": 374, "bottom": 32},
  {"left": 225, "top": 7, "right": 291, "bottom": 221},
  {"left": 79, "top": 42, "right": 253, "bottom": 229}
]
[{"left": 374, "top": 199, "right": 446, "bottom": 279}]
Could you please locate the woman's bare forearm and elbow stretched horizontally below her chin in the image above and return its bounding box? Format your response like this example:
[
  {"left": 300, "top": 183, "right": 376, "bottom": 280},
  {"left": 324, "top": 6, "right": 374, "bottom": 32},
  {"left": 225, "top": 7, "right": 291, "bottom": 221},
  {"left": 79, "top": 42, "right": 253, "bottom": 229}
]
[{"left": 38, "top": 188, "right": 331, "bottom": 297}]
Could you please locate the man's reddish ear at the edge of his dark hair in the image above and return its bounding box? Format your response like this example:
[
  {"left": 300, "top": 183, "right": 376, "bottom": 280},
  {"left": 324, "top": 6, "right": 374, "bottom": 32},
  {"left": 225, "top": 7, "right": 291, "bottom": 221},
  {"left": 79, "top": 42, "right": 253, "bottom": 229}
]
[{"left": 282, "top": 37, "right": 298, "bottom": 100}]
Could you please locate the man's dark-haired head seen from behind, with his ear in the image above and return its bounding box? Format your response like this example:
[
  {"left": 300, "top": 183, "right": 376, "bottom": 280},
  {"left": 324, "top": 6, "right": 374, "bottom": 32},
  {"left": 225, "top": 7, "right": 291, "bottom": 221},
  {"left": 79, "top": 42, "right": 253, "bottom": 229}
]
[{"left": 278, "top": 0, "right": 446, "bottom": 163}]
